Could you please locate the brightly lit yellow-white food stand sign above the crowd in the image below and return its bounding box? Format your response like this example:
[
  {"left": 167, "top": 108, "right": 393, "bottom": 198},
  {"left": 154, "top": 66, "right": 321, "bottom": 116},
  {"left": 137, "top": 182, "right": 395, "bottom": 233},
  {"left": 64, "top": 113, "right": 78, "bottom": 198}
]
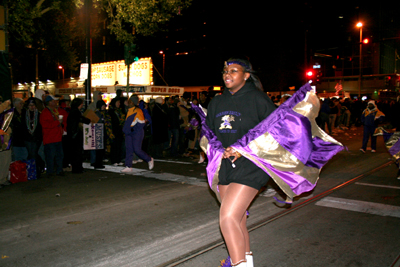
[{"left": 92, "top": 58, "right": 153, "bottom": 86}]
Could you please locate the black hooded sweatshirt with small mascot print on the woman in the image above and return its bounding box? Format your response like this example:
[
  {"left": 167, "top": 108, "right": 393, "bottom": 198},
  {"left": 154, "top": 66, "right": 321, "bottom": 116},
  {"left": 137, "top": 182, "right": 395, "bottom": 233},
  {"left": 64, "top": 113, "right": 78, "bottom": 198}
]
[{"left": 206, "top": 81, "right": 276, "bottom": 148}]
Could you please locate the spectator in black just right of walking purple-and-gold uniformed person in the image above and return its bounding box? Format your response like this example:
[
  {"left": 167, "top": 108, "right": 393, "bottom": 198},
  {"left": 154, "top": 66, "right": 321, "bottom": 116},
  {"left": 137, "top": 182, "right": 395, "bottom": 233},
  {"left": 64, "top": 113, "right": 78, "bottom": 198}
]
[{"left": 152, "top": 97, "right": 168, "bottom": 158}]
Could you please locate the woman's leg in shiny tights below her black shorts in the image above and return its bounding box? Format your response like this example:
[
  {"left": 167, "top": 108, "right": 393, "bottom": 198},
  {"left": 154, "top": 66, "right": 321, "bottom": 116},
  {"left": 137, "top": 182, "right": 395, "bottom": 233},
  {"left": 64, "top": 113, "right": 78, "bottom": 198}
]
[{"left": 219, "top": 183, "right": 258, "bottom": 263}]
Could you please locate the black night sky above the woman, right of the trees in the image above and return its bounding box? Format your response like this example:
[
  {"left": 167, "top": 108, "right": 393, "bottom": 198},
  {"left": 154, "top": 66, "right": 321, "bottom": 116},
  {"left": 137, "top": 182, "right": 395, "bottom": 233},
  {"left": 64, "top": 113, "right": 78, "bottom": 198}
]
[{"left": 155, "top": 0, "right": 400, "bottom": 90}]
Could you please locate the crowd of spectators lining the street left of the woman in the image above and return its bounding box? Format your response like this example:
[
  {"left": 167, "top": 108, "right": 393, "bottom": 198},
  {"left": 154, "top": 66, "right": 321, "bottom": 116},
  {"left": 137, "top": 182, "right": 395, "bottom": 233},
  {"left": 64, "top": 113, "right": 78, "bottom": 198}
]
[{"left": 0, "top": 90, "right": 210, "bottom": 182}]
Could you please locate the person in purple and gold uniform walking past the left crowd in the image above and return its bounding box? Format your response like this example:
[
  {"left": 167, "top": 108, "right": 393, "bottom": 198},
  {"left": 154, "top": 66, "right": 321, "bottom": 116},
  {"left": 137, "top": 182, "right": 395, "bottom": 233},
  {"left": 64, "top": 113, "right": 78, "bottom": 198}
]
[{"left": 121, "top": 95, "right": 154, "bottom": 173}]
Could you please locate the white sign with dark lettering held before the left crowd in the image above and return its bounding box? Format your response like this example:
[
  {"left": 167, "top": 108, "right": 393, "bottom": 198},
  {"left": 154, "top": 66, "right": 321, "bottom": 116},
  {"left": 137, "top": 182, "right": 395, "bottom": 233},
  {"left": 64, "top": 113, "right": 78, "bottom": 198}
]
[{"left": 83, "top": 123, "right": 104, "bottom": 150}]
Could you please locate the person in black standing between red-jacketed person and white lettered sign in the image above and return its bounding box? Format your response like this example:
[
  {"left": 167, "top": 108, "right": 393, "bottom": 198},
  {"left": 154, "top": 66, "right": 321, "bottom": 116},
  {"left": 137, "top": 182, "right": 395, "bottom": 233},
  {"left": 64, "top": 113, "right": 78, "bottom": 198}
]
[{"left": 67, "top": 98, "right": 90, "bottom": 173}]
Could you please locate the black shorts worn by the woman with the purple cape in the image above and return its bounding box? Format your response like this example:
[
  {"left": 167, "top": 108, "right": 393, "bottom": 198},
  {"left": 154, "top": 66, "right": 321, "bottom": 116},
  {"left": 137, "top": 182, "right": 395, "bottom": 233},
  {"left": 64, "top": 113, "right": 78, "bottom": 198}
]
[{"left": 218, "top": 157, "right": 270, "bottom": 190}]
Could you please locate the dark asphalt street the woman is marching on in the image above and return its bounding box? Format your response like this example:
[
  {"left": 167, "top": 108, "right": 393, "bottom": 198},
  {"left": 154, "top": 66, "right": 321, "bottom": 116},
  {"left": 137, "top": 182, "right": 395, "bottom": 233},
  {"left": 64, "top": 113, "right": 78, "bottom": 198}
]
[{"left": 0, "top": 128, "right": 400, "bottom": 267}]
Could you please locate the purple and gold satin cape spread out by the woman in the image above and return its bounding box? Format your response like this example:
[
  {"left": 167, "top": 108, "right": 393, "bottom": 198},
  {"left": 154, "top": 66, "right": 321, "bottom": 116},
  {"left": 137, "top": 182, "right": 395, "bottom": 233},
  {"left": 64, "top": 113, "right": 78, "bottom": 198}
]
[{"left": 193, "top": 84, "right": 344, "bottom": 199}]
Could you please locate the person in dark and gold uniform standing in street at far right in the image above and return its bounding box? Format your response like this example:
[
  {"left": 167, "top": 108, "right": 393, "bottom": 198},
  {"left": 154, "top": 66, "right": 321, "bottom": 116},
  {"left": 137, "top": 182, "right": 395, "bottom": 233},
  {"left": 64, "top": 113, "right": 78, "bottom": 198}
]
[{"left": 360, "top": 100, "right": 385, "bottom": 153}]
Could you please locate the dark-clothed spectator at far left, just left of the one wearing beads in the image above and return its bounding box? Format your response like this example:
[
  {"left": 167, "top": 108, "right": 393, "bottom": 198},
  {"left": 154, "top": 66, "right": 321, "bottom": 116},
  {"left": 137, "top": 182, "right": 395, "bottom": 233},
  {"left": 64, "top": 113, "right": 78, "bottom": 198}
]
[{"left": 11, "top": 98, "right": 28, "bottom": 161}]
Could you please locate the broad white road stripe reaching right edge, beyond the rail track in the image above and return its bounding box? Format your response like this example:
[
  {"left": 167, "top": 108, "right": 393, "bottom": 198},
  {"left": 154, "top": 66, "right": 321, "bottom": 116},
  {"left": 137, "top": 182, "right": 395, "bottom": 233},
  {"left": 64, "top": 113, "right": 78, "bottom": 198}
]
[{"left": 315, "top": 197, "right": 400, "bottom": 218}]
